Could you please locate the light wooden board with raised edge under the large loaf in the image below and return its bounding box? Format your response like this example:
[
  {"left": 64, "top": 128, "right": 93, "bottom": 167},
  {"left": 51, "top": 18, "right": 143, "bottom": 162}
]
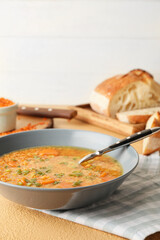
[{"left": 70, "top": 104, "right": 145, "bottom": 136}]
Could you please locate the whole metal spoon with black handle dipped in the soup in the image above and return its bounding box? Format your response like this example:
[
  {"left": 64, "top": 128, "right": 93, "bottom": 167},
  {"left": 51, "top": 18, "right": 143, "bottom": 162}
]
[{"left": 78, "top": 127, "right": 160, "bottom": 164}]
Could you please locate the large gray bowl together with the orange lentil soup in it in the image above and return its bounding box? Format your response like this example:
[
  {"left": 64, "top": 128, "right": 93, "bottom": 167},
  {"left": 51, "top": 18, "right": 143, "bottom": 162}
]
[{"left": 0, "top": 129, "right": 138, "bottom": 210}]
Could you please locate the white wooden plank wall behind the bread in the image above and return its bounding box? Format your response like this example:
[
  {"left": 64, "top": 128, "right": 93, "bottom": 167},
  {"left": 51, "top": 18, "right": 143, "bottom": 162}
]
[{"left": 0, "top": 0, "right": 160, "bottom": 104}]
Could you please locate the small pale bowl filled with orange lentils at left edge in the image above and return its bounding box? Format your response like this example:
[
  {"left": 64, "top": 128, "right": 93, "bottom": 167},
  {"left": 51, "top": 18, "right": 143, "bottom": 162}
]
[{"left": 0, "top": 97, "right": 18, "bottom": 133}]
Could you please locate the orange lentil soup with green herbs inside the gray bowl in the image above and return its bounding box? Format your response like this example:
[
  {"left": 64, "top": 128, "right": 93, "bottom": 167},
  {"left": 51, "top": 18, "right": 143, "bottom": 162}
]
[{"left": 0, "top": 146, "right": 123, "bottom": 188}]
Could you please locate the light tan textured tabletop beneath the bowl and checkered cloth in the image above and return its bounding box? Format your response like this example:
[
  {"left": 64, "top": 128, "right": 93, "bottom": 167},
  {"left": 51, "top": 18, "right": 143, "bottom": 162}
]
[{"left": 0, "top": 119, "right": 160, "bottom": 240}]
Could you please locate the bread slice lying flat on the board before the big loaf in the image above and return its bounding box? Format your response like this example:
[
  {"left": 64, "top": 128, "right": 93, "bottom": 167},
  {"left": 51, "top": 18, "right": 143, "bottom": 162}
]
[{"left": 116, "top": 107, "right": 160, "bottom": 124}]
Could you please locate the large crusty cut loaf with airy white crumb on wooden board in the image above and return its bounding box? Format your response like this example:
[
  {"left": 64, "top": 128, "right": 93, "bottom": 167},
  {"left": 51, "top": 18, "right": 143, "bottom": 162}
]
[{"left": 90, "top": 69, "right": 160, "bottom": 118}]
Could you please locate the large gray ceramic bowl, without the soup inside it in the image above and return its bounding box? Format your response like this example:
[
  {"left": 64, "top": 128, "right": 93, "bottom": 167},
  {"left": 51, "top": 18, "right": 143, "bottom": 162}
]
[{"left": 0, "top": 129, "right": 138, "bottom": 210}]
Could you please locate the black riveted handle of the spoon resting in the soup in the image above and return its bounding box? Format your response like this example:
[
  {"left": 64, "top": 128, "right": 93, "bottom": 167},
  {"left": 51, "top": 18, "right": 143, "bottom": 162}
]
[{"left": 98, "top": 127, "right": 160, "bottom": 155}]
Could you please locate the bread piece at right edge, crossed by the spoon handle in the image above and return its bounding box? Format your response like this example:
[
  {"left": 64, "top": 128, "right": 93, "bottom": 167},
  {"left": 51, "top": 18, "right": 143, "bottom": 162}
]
[{"left": 142, "top": 112, "right": 160, "bottom": 155}]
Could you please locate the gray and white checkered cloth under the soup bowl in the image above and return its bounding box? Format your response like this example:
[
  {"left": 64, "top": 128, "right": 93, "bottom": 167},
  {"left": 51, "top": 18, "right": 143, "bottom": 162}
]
[{"left": 40, "top": 152, "right": 160, "bottom": 240}]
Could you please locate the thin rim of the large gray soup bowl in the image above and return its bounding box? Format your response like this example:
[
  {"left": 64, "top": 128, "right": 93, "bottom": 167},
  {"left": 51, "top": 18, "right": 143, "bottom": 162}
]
[{"left": 0, "top": 128, "right": 139, "bottom": 192}]
